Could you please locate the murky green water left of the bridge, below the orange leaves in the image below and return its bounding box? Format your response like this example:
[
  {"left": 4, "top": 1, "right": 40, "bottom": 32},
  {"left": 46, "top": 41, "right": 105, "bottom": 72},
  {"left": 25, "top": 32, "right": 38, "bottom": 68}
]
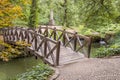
[{"left": 0, "top": 57, "right": 41, "bottom": 80}]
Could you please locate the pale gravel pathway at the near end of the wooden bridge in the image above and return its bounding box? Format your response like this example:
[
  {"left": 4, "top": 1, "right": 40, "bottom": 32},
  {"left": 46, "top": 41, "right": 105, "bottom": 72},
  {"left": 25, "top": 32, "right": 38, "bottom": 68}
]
[{"left": 56, "top": 58, "right": 120, "bottom": 80}]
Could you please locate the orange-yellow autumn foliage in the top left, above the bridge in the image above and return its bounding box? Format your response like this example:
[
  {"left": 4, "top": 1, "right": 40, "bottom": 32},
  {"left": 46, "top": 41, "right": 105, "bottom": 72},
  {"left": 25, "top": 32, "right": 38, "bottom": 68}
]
[{"left": 0, "top": 0, "right": 22, "bottom": 27}]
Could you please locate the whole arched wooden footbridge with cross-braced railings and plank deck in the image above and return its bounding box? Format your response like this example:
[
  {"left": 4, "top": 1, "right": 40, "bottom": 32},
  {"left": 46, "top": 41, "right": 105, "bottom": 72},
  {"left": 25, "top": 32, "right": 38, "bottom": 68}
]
[{"left": 3, "top": 26, "right": 91, "bottom": 66}]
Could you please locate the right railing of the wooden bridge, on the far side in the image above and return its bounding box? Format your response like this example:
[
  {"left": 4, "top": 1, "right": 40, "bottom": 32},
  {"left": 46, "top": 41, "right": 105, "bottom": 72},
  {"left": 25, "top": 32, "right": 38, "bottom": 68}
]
[{"left": 37, "top": 26, "right": 91, "bottom": 58}]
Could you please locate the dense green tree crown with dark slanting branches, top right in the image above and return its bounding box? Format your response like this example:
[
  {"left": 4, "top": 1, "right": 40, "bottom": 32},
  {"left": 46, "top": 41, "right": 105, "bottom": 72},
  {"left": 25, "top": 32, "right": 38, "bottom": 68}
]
[{"left": 80, "top": 0, "right": 117, "bottom": 29}]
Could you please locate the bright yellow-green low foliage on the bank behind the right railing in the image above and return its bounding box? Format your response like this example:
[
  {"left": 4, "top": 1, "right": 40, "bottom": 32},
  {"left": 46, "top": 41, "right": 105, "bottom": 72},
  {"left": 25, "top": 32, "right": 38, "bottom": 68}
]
[{"left": 72, "top": 24, "right": 120, "bottom": 38}]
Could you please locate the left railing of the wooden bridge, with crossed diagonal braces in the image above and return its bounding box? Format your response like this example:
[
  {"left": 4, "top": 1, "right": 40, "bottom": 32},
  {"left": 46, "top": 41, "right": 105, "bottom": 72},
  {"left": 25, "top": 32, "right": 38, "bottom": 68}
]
[{"left": 3, "top": 27, "right": 60, "bottom": 66}]
